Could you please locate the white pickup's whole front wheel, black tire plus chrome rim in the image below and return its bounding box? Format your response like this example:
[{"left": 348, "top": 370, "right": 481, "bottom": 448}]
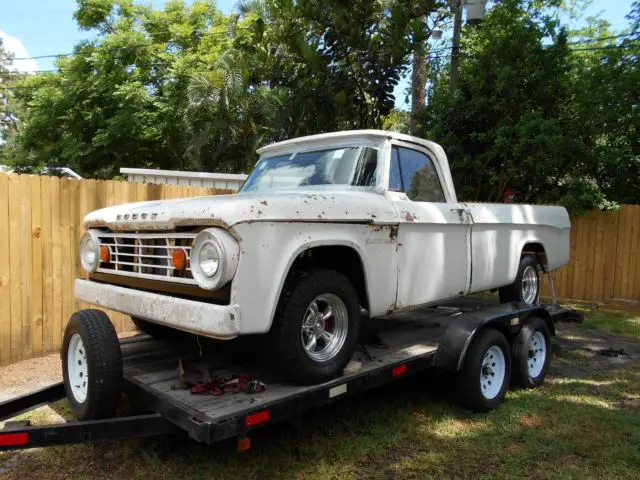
[{"left": 270, "top": 270, "right": 360, "bottom": 384}]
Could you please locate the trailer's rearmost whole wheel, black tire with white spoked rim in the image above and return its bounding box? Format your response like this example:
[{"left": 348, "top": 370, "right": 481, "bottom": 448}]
[{"left": 513, "top": 317, "right": 551, "bottom": 388}]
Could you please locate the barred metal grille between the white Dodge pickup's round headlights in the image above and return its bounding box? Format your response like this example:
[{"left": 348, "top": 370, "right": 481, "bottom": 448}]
[{"left": 97, "top": 232, "right": 196, "bottom": 285}]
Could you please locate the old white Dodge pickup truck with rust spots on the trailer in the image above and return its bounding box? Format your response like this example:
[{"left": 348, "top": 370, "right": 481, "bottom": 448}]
[{"left": 72, "top": 130, "right": 570, "bottom": 386}]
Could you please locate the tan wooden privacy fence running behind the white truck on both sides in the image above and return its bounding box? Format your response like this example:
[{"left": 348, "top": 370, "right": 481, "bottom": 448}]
[{"left": 0, "top": 174, "right": 640, "bottom": 365}]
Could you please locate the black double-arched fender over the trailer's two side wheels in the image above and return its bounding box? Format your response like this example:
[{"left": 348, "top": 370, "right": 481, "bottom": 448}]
[{"left": 435, "top": 303, "right": 555, "bottom": 372}]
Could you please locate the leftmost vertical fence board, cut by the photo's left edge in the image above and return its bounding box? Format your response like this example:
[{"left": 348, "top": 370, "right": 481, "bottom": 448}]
[{"left": 0, "top": 173, "right": 12, "bottom": 365}]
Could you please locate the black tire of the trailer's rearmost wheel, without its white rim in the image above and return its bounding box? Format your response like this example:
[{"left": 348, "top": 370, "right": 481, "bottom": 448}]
[{"left": 512, "top": 317, "right": 551, "bottom": 388}]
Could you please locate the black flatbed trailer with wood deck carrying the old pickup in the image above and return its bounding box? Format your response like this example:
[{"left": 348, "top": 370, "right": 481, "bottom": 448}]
[{"left": 0, "top": 299, "right": 581, "bottom": 451}]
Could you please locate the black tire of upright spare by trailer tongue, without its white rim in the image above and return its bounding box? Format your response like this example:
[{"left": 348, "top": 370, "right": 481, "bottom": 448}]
[{"left": 60, "top": 310, "right": 122, "bottom": 420}]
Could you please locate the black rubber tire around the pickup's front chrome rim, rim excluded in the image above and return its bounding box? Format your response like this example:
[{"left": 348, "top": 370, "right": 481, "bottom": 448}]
[{"left": 268, "top": 269, "right": 360, "bottom": 385}]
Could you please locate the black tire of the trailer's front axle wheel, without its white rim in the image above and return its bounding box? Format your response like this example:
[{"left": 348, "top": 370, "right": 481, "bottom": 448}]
[{"left": 455, "top": 328, "right": 511, "bottom": 412}]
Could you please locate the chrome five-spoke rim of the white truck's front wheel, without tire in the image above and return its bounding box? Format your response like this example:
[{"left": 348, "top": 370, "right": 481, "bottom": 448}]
[{"left": 300, "top": 293, "right": 349, "bottom": 362}]
